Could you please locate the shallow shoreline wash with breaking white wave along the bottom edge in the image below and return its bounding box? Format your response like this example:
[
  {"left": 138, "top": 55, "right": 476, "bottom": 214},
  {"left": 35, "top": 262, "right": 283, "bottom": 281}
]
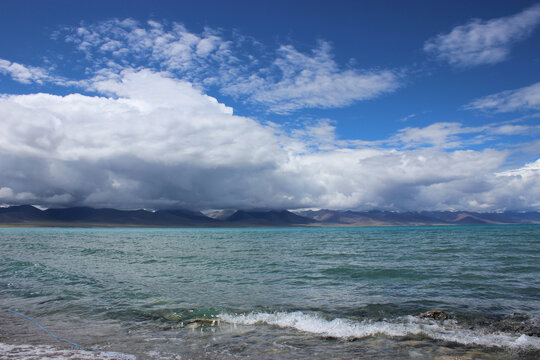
[{"left": 4, "top": 311, "right": 539, "bottom": 360}]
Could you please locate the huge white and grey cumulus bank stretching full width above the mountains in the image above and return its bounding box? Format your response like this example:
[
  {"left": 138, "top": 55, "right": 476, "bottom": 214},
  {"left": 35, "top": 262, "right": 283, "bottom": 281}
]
[{"left": 0, "top": 69, "right": 540, "bottom": 210}]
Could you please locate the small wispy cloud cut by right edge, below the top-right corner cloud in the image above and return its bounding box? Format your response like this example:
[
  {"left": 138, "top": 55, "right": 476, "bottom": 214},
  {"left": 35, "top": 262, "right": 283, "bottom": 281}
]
[{"left": 464, "top": 82, "right": 540, "bottom": 113}]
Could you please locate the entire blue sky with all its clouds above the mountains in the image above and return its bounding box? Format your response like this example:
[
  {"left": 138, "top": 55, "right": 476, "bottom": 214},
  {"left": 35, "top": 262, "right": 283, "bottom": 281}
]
[{"left": 0, "top": 0, "right": 540, "bottom": 212}]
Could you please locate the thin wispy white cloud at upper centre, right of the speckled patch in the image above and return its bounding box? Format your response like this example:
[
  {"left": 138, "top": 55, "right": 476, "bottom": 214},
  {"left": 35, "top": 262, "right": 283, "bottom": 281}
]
[{"left": 220, "top": 42, "right": 401, "bottom": 113}]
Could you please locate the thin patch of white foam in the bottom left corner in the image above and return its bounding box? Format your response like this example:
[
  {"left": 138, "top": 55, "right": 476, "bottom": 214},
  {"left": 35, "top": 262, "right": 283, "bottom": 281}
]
[{"left": 0, "top": 343, "right": 136, "bottom": 360}]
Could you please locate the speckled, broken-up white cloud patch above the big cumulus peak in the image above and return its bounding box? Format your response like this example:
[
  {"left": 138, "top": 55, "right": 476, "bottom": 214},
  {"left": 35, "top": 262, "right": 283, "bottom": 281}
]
[{"left": 66, "top": 18, "right": 234, "bottom": 82}]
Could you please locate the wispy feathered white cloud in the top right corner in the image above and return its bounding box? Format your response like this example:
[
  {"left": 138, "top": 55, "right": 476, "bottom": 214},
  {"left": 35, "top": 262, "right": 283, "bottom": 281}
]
[{"left": 424, "top": 5, "right": 540, "bottom": 67}]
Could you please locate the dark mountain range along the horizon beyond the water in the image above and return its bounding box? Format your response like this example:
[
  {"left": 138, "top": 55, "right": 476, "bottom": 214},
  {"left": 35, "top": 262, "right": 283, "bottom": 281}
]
[{"left": 0, "top": 205, "right": 540, "bottom": 227}]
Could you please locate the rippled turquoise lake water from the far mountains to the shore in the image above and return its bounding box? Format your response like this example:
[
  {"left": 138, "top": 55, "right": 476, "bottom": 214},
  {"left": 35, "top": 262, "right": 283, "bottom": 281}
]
[{"left": 0, "top": 225, "right": 540, "bottom": 359}]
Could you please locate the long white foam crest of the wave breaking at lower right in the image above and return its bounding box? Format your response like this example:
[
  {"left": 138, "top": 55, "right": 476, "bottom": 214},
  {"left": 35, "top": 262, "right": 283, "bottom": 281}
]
[{"left": 220, "top": 311, "right": 540, "bottom": 350}]
